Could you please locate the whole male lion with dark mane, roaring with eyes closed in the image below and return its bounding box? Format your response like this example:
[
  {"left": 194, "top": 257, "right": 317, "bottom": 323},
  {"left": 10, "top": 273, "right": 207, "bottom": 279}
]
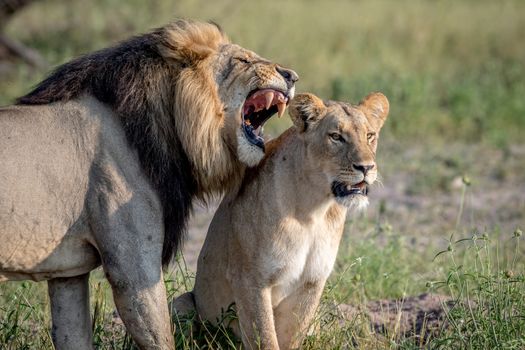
[{"left": 0, "top": 20, "right": 297, "bottom": 349}]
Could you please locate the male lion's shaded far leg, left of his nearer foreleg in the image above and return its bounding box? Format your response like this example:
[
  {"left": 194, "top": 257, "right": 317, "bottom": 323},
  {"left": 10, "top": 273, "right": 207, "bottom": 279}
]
[{"left": 47, "top": 273, "right": 93, "bottom": 350}]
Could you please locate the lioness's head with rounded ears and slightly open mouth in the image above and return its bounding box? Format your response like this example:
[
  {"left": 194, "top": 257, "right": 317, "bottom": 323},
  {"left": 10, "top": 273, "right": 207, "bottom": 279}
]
[{"left": 290, "top": 93, "right": 389, "bottom": 208}]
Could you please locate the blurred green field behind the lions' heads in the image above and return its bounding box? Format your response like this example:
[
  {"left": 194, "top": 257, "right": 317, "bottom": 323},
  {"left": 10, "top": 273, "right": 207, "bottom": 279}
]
[{"left": 0, "top": 0, "right": 525, "bottom": 147}]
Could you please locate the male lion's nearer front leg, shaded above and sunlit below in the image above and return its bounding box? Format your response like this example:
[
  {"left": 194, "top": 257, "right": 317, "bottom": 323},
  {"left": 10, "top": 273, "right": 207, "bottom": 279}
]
[{"left": 91, "top": 187, "right": 174, "bottom": 349}]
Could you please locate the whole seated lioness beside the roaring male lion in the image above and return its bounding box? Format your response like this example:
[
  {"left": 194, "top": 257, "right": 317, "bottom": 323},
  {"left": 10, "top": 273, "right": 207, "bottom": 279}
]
[{"left": 173, "top": 93, "right": 389, "bottom": 350}]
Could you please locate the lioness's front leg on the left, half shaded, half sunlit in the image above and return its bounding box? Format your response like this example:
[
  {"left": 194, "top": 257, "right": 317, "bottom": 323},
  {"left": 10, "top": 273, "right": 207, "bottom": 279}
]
[{"left": 233, "top": 280, "right": 279, "bottom": 350}]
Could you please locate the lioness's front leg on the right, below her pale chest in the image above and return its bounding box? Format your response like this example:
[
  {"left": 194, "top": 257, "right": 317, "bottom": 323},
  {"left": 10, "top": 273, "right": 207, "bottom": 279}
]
[{"left": 275, "top": 282, "right": 324, "bottom": 350}]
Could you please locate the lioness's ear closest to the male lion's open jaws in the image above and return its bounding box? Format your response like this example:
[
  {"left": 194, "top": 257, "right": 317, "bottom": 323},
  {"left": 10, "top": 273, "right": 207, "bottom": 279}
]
[{"left": 288, "top": 93, "right": 326, "bottom": 132}]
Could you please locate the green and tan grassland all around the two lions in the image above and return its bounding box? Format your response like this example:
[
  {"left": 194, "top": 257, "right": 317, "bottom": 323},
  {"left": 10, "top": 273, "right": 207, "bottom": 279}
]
[{"left": 0, "top": 0, "right": 525, "bottom": 349}]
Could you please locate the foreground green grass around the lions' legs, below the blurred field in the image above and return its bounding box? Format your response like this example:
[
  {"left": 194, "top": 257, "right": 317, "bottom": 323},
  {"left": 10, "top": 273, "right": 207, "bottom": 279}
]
[{"left": 0, "top": 182, "right": 525, "bottom": 350}]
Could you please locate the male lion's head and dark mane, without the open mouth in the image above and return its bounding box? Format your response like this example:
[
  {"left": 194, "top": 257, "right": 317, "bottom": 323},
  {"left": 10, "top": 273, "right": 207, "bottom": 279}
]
[{"left": 19, "top": 20, "right": 295, "bottom": 264}]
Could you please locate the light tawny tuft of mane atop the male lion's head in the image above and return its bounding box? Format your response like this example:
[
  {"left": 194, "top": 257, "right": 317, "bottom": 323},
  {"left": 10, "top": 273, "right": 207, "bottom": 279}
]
[{"left": 159, "top": 20, "right": 229, "bottom": 65}]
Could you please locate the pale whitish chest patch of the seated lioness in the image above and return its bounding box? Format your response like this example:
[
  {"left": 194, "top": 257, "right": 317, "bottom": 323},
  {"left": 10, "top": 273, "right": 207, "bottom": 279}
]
[{"left": 266, "top": 220, "right": 342, "bottom": 307}]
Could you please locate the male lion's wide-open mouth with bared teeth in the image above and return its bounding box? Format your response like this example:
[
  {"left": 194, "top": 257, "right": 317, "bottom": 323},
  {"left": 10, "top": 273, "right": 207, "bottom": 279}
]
[{"left": 242, "top": 89, "right": 288, "bottom": 150}]
